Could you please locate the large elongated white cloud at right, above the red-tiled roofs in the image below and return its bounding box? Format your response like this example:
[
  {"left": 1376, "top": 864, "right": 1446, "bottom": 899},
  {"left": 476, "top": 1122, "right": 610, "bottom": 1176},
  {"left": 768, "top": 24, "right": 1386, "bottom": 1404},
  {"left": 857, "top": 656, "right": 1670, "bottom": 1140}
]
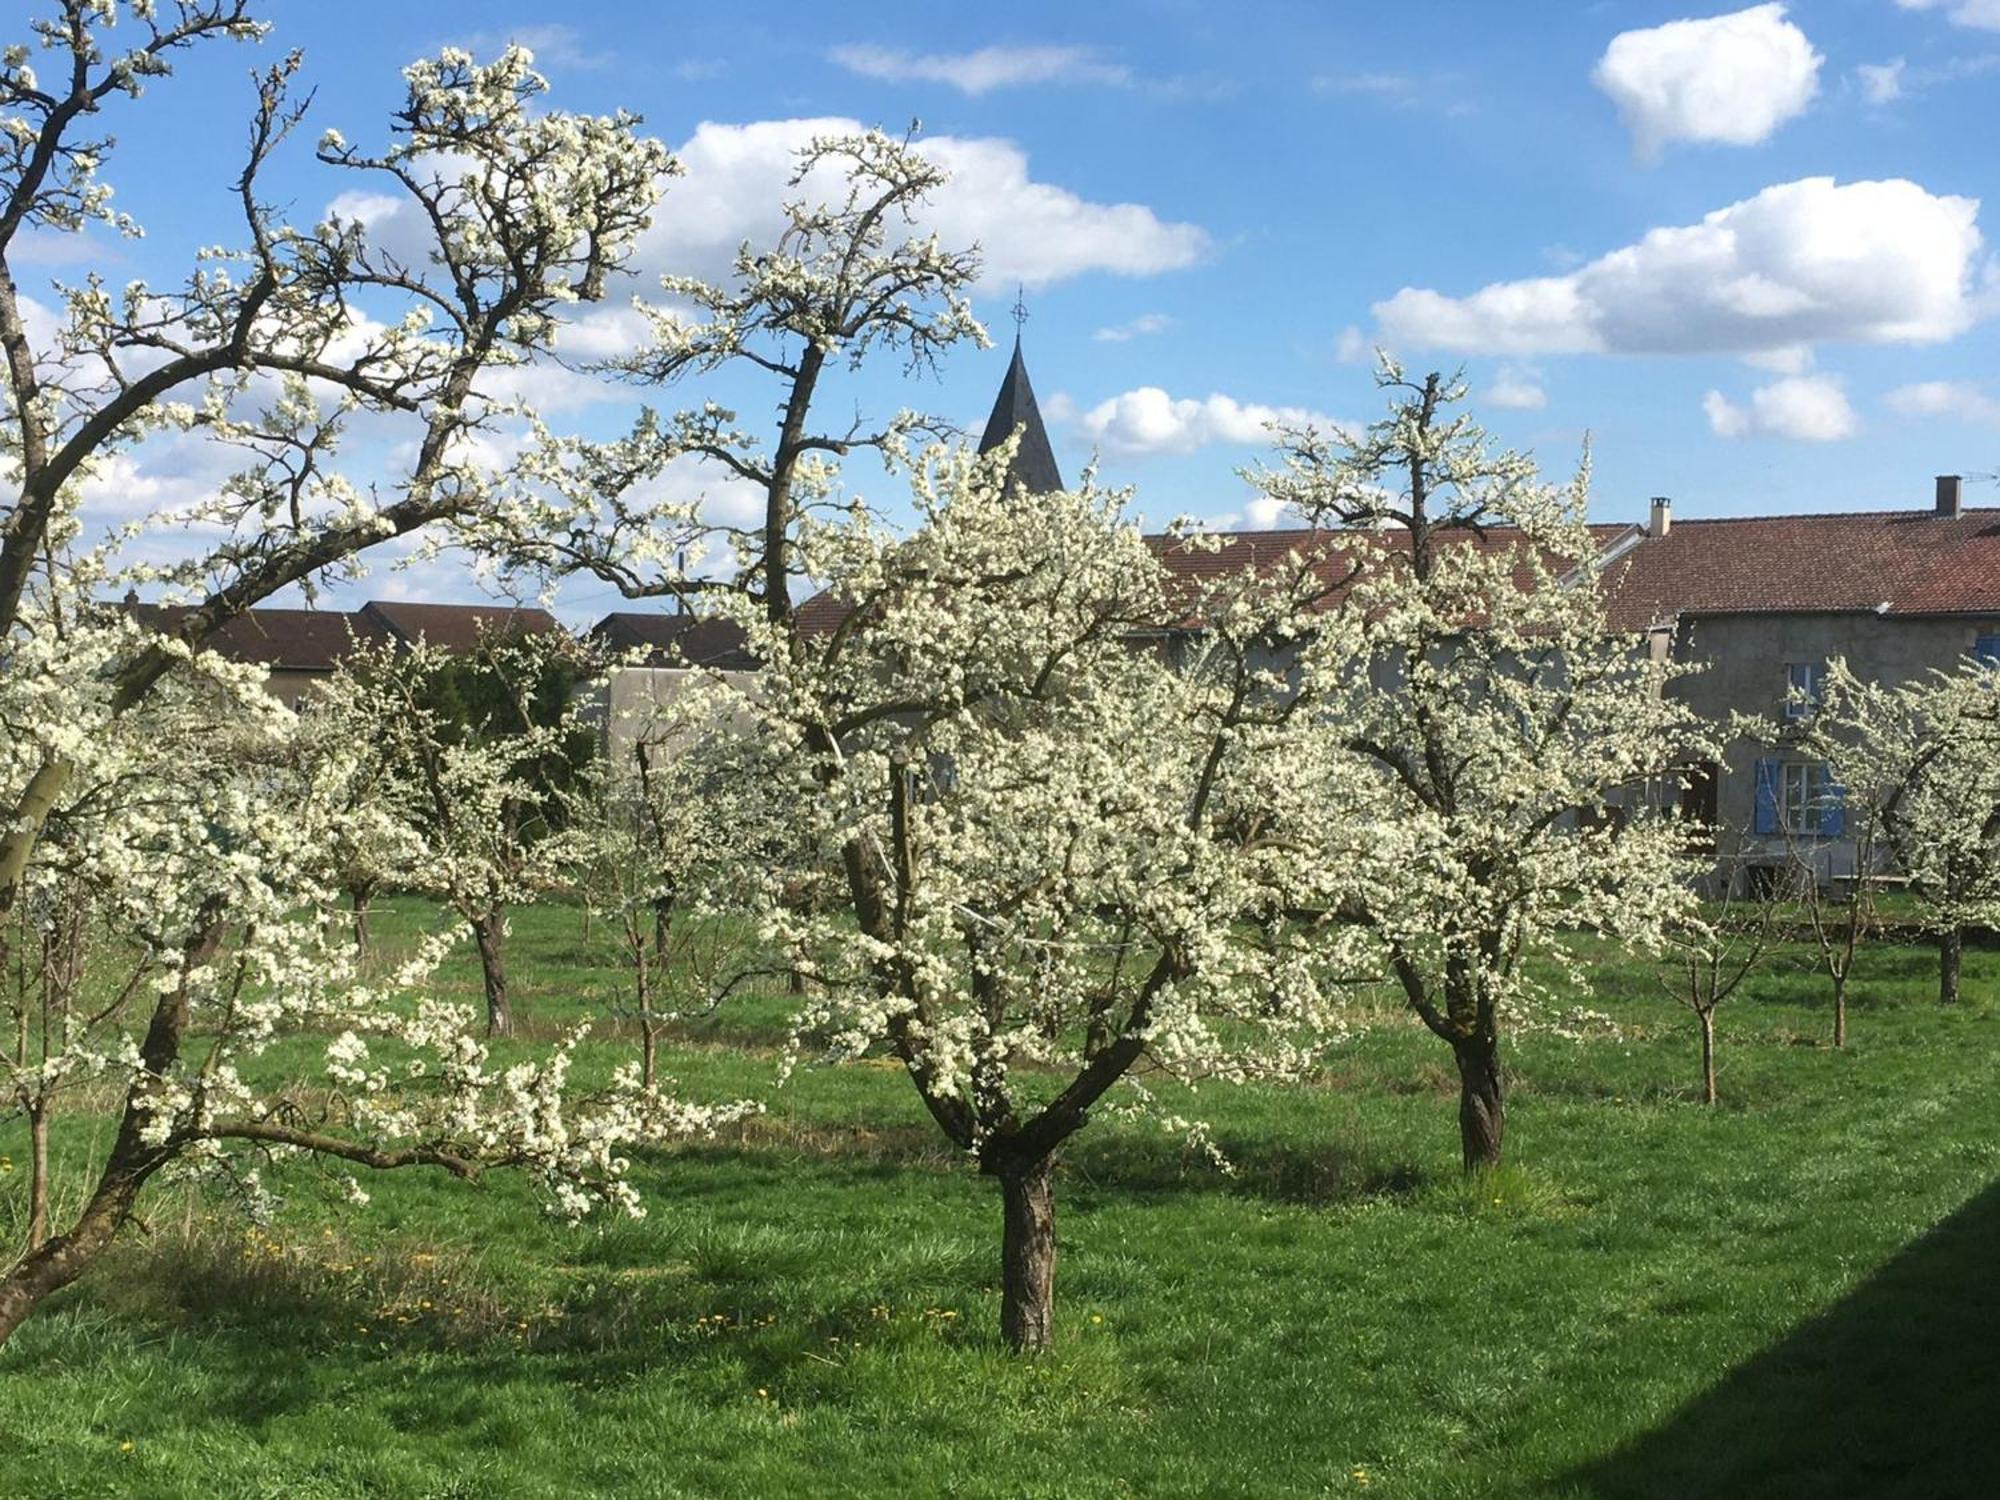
[{"left": 1374, "top": 178, "right": 1982, "bottom": 354}]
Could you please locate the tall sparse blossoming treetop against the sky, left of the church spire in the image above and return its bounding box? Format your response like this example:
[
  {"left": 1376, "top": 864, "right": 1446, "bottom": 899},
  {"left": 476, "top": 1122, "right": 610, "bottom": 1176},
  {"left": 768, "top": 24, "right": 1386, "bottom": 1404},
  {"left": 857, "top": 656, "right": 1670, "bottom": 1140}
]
[{"left": 484, "top": 130, "right": 986, "bottom": 618}]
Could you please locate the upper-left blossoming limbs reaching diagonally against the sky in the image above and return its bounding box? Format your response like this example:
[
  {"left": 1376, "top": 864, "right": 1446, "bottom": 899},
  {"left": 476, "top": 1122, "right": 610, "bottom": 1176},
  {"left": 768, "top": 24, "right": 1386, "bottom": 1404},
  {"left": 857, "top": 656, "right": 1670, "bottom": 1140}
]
[{"left": 0, "top": 14, "right": 676, "bottom": 908}]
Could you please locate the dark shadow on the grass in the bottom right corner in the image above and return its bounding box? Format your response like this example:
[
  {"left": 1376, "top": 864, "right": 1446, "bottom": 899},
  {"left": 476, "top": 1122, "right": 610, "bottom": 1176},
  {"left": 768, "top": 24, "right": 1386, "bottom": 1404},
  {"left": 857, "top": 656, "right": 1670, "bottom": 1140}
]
[{"left": 1570, "top": 1184, "right": 2000, "bottom": 1500}]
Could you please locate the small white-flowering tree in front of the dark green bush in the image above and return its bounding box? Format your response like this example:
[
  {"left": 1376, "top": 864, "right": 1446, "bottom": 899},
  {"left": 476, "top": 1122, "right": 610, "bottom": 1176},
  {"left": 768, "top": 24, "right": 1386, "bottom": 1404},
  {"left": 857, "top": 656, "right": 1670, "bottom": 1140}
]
[{"left": 310, "top": 632, "right": 596, "bottom": 1034}]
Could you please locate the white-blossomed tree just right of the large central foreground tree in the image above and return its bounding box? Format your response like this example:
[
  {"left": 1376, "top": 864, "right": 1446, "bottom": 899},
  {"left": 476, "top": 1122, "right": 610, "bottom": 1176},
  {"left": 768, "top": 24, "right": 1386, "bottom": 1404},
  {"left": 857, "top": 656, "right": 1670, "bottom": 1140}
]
[{"left": 1252, "top": 360, "right": 1710, "bottom": 1170}]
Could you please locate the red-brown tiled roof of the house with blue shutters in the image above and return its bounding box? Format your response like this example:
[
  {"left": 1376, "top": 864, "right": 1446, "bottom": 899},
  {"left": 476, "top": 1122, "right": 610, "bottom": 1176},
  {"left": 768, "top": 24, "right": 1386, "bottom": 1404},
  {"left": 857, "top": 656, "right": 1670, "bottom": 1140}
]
[{"left": 1610, "top": 510, "right": 2000, "bottom": 630}]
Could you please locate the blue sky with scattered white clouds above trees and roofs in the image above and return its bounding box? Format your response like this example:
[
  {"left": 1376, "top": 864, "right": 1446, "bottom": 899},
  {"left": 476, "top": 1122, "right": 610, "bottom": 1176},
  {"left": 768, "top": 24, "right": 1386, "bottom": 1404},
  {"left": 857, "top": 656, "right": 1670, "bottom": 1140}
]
[{"left": 28, "top": 0, "right": 2000, "bottom": 612}]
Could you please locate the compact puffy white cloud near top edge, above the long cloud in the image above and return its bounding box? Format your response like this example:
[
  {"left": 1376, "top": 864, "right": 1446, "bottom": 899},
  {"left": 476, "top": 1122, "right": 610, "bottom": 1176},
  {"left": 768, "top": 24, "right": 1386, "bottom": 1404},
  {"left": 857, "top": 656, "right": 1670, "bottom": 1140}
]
[{"left": 1590, "top": 4, "right": 1826, "bottom": 158}]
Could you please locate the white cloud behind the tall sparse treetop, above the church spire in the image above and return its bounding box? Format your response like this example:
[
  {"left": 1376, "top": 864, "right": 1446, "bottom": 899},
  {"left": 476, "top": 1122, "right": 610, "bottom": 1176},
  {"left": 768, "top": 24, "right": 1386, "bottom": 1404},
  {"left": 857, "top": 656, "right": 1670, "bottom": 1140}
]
[{"left": 640, "top": 118, "right": 1210, "bottom": 286}]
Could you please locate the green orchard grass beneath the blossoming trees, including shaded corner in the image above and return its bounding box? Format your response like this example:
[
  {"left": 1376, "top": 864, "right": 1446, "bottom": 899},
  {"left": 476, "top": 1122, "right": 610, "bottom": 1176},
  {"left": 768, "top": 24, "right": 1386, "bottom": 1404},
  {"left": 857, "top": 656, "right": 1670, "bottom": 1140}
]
[{"left": 0, "top": 908, "right": 2000, "bottom": 1500}]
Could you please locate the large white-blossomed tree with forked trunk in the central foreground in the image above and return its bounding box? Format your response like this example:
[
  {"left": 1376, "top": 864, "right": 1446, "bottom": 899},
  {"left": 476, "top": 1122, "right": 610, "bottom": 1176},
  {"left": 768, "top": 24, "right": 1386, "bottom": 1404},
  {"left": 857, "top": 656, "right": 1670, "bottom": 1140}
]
[{"left": 684, "top": 448, "right": 1332, "bottom": 1350}]
